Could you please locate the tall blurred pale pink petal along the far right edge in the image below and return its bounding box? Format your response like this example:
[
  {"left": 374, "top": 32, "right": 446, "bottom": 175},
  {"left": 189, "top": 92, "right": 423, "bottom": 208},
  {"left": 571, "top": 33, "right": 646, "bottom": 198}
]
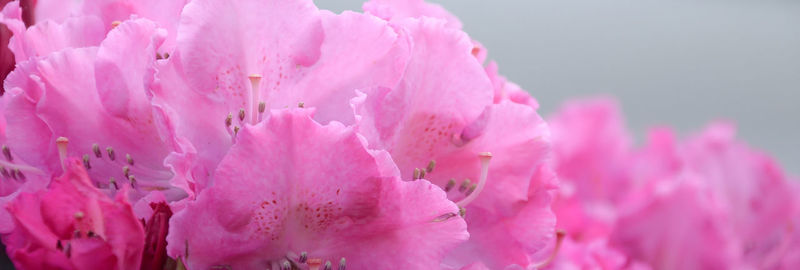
[{"left": 685, "top": 123, "right": 799, "bottom": 268}]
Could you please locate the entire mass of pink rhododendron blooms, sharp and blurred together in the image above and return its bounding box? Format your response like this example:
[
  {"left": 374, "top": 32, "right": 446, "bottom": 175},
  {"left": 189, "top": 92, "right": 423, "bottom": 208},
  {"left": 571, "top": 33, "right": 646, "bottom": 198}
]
[{"left": 0, "top": 0, "right": 800, "bottom": 270}]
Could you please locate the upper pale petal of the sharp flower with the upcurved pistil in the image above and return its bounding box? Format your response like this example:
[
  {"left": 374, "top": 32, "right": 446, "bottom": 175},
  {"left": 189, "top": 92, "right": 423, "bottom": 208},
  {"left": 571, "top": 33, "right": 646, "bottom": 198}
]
[{"left": 356, "top": 17, "right": 492, "bottom": 176}]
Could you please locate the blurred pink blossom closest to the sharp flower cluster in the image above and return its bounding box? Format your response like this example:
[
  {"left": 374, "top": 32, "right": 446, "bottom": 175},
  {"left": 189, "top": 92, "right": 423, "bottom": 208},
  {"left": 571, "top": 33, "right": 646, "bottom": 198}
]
[{"left": 548, "top": 99, "right": 632, "bottom": 240}]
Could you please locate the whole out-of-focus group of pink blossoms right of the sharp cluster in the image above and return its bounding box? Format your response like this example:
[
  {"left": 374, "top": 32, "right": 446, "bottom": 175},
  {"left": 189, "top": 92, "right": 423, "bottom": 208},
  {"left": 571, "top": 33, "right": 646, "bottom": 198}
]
[{"left": 550, "top": 100, "right": 798, "bottom": 269}]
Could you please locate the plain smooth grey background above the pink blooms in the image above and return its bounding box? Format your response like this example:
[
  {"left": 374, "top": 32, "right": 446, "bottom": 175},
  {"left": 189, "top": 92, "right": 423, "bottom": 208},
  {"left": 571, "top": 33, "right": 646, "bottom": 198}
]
[{"left": 316, "top": 0, "right": 800, "bottom": 175}]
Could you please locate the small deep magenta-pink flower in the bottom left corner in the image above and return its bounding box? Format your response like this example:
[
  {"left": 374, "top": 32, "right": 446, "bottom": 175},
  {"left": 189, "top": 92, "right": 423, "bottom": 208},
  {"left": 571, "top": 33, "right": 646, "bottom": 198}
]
[{"left": 4, "top": 159, "right": 144, "bottom": 269}]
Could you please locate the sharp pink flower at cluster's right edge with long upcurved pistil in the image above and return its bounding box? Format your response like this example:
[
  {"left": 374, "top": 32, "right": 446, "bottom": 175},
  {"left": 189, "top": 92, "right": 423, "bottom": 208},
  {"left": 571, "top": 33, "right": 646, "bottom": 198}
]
[{"left": 354, "top": 18, "right": 554, "bottom": 268}]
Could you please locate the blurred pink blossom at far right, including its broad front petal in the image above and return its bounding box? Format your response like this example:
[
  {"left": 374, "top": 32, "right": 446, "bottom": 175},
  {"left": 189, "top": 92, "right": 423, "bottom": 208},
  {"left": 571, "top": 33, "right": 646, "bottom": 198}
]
[{"left": 612, "top": 123, "right": 798, "bottom": 269}]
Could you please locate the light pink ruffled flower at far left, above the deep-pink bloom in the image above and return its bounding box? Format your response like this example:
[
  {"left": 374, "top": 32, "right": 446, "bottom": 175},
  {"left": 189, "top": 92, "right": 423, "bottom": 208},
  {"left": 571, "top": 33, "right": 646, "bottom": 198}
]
[{"left": 4, "top": 16, "right": 186, "bottom": 225}]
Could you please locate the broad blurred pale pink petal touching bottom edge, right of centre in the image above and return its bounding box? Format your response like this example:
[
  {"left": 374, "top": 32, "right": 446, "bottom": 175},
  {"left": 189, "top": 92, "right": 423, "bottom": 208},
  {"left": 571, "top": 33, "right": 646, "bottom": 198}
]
[{"left": 610, "top": 177, "right": 742, "bottom": 269}]
